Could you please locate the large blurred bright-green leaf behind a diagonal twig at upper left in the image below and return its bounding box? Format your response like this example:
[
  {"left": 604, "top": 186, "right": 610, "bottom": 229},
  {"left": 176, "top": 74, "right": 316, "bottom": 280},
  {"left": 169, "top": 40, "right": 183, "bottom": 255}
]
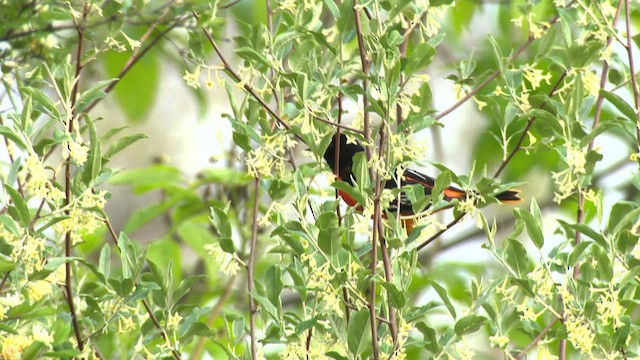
[{"left": 103, "top": 50, "right": 160, "bottom": 123}]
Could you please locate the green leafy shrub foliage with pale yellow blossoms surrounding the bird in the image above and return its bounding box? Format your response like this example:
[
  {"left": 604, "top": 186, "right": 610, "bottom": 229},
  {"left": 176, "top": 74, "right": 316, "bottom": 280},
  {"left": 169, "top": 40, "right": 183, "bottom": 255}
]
[{"left": 0, "top": 0, "right": 640, "bottom": 359}]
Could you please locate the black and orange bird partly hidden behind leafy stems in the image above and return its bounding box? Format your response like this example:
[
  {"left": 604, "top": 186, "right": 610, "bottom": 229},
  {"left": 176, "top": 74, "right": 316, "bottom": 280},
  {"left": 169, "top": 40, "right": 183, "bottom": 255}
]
[{"left": 324, "top": 134, "right": 522, "bottom": 233}]
